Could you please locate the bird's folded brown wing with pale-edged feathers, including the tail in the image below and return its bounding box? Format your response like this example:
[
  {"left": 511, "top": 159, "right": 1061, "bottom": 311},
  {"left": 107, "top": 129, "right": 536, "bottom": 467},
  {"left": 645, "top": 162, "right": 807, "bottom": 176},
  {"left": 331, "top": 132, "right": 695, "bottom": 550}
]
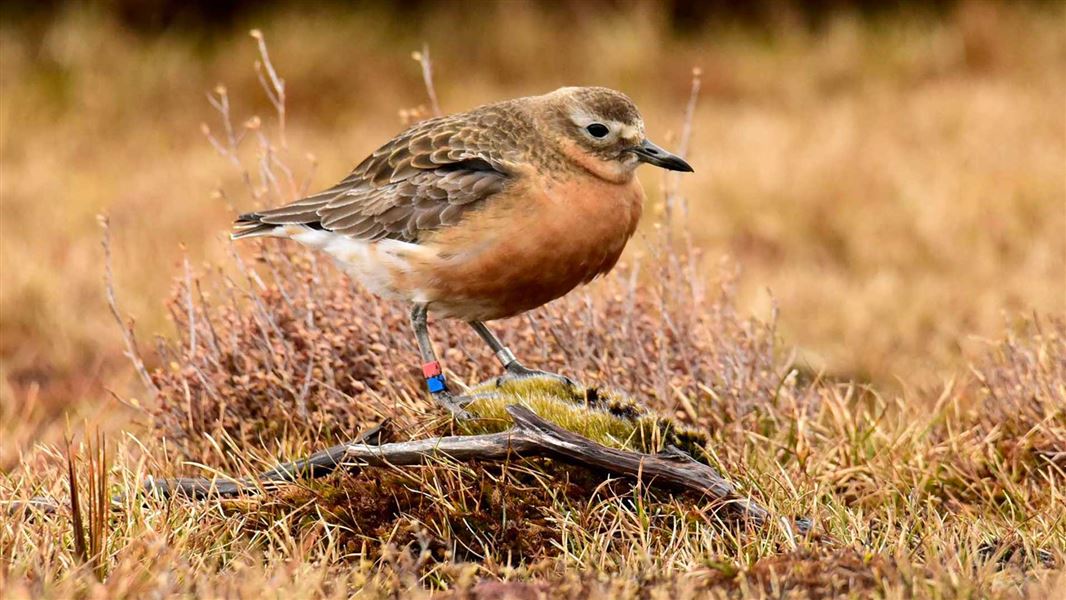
[{"left": 235, "top": 104, "right": 528, "bottom": 242}]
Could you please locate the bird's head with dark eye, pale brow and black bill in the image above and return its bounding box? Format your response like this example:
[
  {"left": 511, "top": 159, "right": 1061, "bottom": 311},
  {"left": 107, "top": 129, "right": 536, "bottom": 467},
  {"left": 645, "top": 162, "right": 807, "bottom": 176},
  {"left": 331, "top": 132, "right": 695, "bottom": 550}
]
[{"left": 544, "top": 87, "right": 692, "bottom": 180}]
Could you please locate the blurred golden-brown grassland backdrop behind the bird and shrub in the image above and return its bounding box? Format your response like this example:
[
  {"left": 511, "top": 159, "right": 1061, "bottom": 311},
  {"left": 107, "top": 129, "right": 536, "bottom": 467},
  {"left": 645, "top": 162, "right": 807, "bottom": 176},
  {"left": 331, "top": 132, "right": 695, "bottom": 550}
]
[{"left": 0, "top": 0, "right": 1066, "bottom": 466}]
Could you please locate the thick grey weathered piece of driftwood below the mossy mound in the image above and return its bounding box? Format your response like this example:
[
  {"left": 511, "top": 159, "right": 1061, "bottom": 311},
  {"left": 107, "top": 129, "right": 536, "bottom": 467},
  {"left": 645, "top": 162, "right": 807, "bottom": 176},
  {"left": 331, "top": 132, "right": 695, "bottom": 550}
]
[{"left": 348, "top": 405, "right": 780, "bottom": 530}]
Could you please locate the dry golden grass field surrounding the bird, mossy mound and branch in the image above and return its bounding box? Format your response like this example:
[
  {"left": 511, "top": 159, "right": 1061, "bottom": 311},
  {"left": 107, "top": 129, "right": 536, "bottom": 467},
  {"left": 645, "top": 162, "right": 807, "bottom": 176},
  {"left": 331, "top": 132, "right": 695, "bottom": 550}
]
[{"left": 0, "top": 2, "right": 1066, "bottom": 598}]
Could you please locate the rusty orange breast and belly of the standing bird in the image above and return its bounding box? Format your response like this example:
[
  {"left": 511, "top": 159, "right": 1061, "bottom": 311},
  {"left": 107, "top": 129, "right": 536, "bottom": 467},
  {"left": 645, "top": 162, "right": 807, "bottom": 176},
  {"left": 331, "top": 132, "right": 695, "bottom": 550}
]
[{"left": 405, "top": 175, "right": 644, "bottom": 321}]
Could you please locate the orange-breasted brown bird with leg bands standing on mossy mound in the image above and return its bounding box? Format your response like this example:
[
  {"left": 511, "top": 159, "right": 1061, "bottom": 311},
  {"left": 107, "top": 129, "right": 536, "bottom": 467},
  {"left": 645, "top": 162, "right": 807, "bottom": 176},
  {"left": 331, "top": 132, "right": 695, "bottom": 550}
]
[{"left": 231, "top": 86, "right": 693, "bottom": 419}]
